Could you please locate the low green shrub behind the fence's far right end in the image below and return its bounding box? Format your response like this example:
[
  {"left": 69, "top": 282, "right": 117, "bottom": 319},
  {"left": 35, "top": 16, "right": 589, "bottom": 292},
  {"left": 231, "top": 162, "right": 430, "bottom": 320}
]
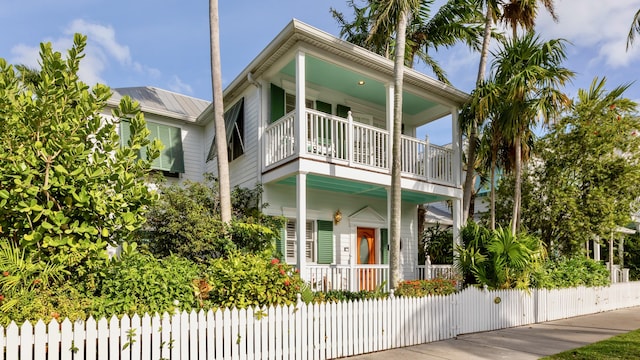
[{"left": 534, "top": 256, "right": 609, "bottom": 289}]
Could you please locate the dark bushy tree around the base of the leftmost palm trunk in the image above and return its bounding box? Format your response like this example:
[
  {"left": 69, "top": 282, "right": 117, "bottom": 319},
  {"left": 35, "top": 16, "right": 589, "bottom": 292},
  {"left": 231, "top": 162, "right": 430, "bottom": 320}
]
[{"left": 141, "top": 174, "right": 284, "bottom": 263}]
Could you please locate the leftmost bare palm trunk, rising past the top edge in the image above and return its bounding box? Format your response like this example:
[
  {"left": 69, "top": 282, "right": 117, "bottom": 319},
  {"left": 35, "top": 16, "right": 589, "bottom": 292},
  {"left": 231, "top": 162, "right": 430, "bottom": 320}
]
[{"left": 209, "top": 0, "right": 231, "bottom": 223}]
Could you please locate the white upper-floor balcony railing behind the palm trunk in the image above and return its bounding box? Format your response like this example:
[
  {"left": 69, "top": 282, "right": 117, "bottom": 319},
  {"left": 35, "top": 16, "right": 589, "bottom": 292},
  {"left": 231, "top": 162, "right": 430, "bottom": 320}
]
[{"left": 263, "top": 109, "right": 456, "bottom": 186}]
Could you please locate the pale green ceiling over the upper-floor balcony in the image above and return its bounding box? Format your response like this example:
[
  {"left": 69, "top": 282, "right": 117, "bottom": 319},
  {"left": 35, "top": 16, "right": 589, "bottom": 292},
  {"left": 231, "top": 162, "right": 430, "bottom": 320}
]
[{"left": 280, "top": 54, "right": 438, "bottom": 115}]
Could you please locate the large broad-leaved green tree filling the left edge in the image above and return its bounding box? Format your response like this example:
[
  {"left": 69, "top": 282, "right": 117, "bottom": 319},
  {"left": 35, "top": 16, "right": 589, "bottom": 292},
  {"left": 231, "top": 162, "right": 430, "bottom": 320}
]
[{"left": 0, "top": 34, "right": 161, "bottom": 265}]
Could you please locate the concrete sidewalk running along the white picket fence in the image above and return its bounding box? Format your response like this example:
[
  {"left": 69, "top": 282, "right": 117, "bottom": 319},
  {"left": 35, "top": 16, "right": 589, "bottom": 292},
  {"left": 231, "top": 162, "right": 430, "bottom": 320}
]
[{"left": 348, "top": 307, "right": 640, "bottom": 360}]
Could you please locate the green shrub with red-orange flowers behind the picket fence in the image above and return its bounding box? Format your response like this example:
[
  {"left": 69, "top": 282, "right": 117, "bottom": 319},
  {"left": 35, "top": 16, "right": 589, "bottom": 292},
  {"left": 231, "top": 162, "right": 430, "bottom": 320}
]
[{"left": 205, "top": 251, "right": 303, "bottom": 308}]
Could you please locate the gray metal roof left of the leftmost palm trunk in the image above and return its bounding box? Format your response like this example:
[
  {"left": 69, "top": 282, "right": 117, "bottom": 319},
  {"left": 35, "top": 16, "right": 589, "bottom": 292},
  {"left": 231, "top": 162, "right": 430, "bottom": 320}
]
[{"left": 109, "top": 86, "right": 210, "bottom": 122}]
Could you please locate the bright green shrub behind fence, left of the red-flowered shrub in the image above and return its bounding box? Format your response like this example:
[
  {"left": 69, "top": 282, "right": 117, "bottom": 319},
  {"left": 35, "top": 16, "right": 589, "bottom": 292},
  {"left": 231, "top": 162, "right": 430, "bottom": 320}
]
[{"left": 93, "top": 245, "right": 200, "bottom": 316}]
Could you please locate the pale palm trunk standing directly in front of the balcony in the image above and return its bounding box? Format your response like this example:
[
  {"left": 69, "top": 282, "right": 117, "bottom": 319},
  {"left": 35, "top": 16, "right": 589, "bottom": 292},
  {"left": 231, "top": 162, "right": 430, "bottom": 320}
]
[{"left": 389, "top": 10, "right": 411, "bottom": 289}]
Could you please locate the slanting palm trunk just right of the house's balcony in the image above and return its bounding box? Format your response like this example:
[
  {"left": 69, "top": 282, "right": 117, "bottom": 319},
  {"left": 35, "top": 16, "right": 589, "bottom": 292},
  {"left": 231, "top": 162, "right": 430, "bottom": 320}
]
[{"left": 462, "top": 6, "right": 493, "bottom": 224}]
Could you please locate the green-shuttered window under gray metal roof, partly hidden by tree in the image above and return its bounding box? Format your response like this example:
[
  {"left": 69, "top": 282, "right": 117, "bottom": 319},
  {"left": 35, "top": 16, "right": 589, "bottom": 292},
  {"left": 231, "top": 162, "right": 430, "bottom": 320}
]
[{"left": 120, "top": 120, "right": 184, "bottom": 176}]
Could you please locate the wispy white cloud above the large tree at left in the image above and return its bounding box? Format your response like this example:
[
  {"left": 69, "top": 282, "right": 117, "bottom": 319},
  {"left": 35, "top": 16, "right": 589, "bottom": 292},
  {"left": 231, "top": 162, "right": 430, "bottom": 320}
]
[{"left": 11, "top": 19, "right": 162, "bottom": 85}]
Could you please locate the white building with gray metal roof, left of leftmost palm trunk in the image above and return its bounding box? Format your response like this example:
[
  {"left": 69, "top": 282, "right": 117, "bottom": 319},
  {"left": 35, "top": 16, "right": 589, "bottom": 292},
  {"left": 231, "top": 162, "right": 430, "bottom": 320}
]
[{"left": 105, "top": 86, "right": 210, "bottom": 181}]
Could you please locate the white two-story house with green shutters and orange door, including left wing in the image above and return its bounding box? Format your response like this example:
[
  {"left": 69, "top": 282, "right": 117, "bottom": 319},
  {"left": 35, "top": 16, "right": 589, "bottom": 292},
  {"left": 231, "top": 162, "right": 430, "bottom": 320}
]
[{"left": 113, "top": 20, "right": 468, "bottom": 290}]
